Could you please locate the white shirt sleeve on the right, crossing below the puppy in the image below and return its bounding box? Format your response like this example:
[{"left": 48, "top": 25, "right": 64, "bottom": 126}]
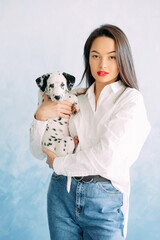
[{"left": 54, "top": 94, "right": 150, "bottom": 180}]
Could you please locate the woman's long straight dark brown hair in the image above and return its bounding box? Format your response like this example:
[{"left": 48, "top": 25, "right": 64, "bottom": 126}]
[{"left": 81, "top": 24, "right": 138, "bottom": 89}]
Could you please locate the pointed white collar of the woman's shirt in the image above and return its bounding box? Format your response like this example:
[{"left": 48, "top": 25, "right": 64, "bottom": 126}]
[{"left": 86, "top": 80, "right": 125, "bottom": 98}]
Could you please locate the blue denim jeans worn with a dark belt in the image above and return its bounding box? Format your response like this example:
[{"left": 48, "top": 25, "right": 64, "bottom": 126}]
[{"left": 47, "top": 173, "right": 124, "bottom": 240}]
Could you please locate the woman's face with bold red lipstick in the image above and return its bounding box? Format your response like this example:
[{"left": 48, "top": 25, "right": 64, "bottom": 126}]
[{"left": 89, "top": 36, "right": 119, "bottom": 85}]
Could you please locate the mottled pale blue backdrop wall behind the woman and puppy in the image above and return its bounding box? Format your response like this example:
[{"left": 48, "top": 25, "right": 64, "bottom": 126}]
[{"left": 0, "top": 0, "right": 160, "bottom": 240}]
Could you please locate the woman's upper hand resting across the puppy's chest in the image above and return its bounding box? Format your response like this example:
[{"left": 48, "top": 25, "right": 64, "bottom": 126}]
[{"left": 35, "top": 94, "right": 72, "bottom": 121}]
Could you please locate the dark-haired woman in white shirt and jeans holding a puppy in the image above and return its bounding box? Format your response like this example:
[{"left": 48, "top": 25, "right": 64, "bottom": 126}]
[{"left": 30, "top": 25, "right": 150, "bottom": 240}]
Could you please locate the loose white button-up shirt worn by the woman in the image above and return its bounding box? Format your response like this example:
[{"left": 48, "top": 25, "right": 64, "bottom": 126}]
[{"left": 30, "top": 80, "right": 150, "bottom": 235}]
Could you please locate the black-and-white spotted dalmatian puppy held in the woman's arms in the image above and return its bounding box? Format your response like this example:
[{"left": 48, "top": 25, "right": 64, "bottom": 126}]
[{"left": 36, "top": 72, "right": 79, "bottom": 156}]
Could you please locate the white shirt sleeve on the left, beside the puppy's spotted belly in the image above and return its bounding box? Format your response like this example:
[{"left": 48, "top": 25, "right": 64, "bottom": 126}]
[{"left": 30, "top": 118, "right": 47, "bottom": 160}]
